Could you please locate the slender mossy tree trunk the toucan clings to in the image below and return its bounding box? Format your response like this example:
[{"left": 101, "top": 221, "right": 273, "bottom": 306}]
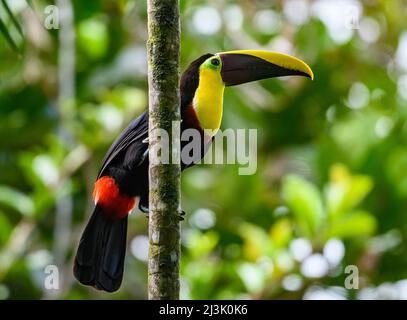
[{"left": 147, "top": 0, "right": 180, "bottom": 299}]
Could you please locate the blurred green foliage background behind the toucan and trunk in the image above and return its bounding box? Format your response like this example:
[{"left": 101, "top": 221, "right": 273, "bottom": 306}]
[{"left": 0, "top": 0, "right": 407, "bottom": 299}]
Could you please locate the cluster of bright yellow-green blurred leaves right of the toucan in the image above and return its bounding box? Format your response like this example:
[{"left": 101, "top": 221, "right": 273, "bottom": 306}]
[{"left": 282, "top": 164, "right": 376, "bottom": 240}]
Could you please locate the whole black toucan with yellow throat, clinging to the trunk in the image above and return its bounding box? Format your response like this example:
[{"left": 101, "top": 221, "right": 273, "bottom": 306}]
[{"left": 74, "top": 50, "right": 314, "bottom": 292}]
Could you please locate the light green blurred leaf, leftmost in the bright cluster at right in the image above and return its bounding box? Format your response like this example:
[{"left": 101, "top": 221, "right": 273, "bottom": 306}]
[{"left": 282, "top": 175, "right": 324, "bottom": 238}]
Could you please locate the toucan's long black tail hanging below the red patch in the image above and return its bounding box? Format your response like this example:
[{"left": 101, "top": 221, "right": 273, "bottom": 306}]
[{"left": 74, "top": 206, "right": 127, "bottom": 292}]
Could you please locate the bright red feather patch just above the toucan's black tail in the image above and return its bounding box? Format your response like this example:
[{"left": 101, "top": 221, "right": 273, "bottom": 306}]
[{"left": 92, "top": 176, "right": 136, "bottom": 219}]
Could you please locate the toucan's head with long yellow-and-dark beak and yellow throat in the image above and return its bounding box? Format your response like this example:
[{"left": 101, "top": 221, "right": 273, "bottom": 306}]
[{"left": 181, "top": 50, "right": 314, "bottom": 130}]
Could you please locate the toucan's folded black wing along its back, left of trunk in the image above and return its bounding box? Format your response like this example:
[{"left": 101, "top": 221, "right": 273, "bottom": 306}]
[{"left": 98, "top": 111, "right": 148, "bottom": 179}]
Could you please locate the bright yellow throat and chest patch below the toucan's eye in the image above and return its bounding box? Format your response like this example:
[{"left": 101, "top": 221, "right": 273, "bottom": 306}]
[{"left": 193, "top": 68, "right": 225, "bottom": 135}]
